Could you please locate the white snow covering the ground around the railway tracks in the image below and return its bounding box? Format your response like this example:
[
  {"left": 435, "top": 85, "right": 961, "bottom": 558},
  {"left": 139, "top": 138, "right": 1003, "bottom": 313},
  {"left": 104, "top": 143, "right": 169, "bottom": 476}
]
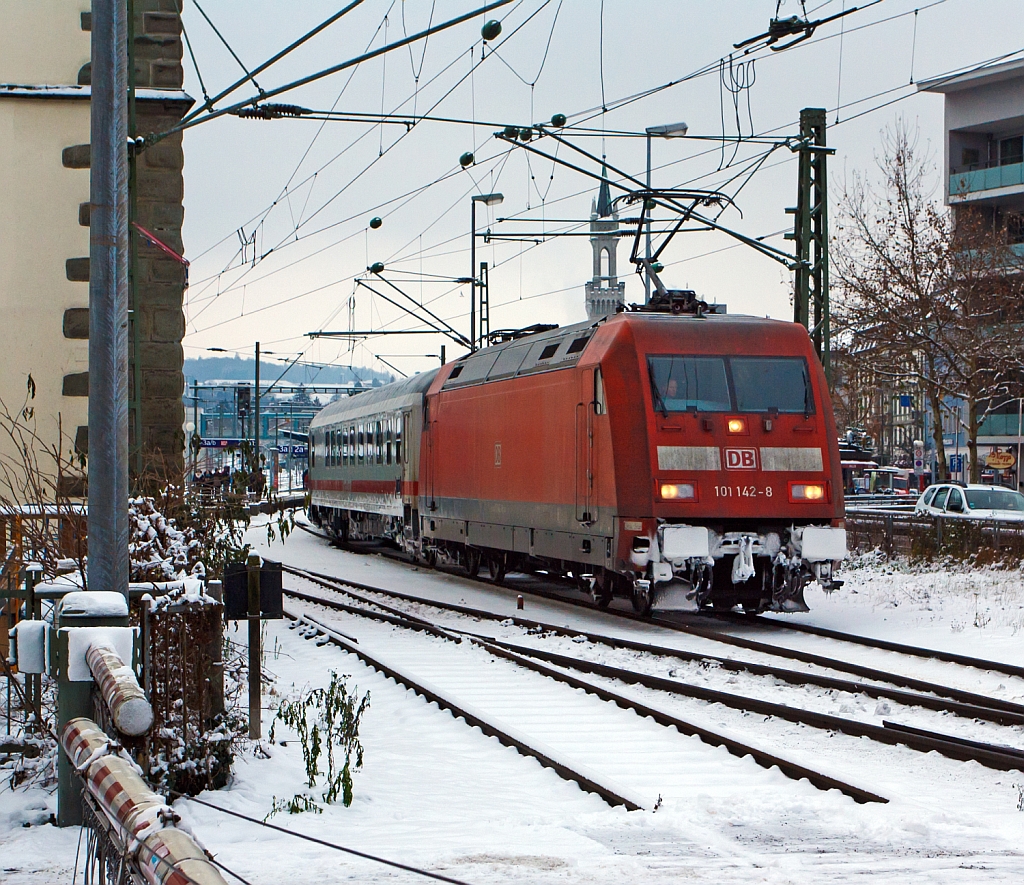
[{"left": 6, "top": 528, "right": 1024, "bottom": 885}]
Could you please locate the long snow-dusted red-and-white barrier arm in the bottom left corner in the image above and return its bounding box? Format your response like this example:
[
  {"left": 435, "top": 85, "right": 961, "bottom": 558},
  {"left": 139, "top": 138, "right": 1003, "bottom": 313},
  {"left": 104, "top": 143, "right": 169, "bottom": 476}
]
[{"left": 60, "top": 718, "right": 227, "bottom": 885}]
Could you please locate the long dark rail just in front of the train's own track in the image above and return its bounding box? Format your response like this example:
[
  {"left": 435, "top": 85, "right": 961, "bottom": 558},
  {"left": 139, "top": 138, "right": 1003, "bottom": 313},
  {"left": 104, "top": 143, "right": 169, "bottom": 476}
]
[{"left": 282, "top": 565, "right": 1024, "bottom": 725}]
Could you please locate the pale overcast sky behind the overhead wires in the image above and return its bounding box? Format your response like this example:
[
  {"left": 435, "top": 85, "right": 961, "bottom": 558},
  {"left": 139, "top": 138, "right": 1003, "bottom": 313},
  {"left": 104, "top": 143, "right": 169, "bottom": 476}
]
[{"left": 184, "top": 0, "right": 1024, "bottom": 374}]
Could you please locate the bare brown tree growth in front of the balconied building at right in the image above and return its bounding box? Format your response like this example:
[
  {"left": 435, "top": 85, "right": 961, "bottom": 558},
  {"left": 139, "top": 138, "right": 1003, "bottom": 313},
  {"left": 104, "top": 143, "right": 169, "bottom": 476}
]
[{"left": 833, "top": 121, "right": 1022, "bottom": 481}]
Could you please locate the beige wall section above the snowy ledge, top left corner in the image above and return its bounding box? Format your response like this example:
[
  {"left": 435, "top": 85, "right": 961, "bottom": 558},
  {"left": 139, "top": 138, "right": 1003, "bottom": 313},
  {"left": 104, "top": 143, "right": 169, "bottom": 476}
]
[{"left": 0, "top": 0, "right": 92, "bottom": 86}]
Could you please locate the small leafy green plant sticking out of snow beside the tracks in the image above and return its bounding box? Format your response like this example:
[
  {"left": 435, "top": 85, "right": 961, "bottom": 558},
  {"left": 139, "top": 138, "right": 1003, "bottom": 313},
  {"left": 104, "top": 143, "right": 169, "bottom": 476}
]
[{"left": 270, "top": 671, "right": 370, "bottom": 813}]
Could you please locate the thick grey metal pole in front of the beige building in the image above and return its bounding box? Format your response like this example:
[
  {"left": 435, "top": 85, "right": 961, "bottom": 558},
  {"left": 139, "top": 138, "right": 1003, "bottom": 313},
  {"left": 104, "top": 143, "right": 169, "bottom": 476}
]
[{"left": 88, "top": 0, "right": 128, "bottom": 597}]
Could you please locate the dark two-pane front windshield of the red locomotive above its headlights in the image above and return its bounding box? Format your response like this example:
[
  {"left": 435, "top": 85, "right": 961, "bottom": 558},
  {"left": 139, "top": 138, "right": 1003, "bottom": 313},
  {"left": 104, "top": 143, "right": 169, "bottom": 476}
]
[{"left": 647, "top": 356, "right": 814, "bottom": 415}]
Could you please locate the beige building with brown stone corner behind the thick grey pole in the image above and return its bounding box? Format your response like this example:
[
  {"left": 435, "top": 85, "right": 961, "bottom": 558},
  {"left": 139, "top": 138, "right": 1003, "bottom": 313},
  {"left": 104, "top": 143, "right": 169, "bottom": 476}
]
[{"left": 0, "top": 0, "right": 193, "bottom": 497}]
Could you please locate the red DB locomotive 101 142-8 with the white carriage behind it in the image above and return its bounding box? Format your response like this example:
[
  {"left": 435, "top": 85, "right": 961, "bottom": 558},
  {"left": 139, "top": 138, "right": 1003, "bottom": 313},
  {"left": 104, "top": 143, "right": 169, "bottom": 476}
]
[{"left": 310, "top": 292, "right": 846, "bottom": 613}]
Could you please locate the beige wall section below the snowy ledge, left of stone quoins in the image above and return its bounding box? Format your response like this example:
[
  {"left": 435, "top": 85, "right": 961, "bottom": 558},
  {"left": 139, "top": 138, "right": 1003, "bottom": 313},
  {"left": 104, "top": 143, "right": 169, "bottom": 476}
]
[{"left": 0, "top": 97, "right": 89, "bottom": 487}]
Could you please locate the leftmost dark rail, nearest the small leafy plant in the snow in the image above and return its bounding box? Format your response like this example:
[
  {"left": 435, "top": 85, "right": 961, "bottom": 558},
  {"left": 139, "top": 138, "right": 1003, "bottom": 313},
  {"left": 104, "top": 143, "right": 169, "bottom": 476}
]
[{"left": 285, "top": 608, "right": 641, "bottom": 811}]
